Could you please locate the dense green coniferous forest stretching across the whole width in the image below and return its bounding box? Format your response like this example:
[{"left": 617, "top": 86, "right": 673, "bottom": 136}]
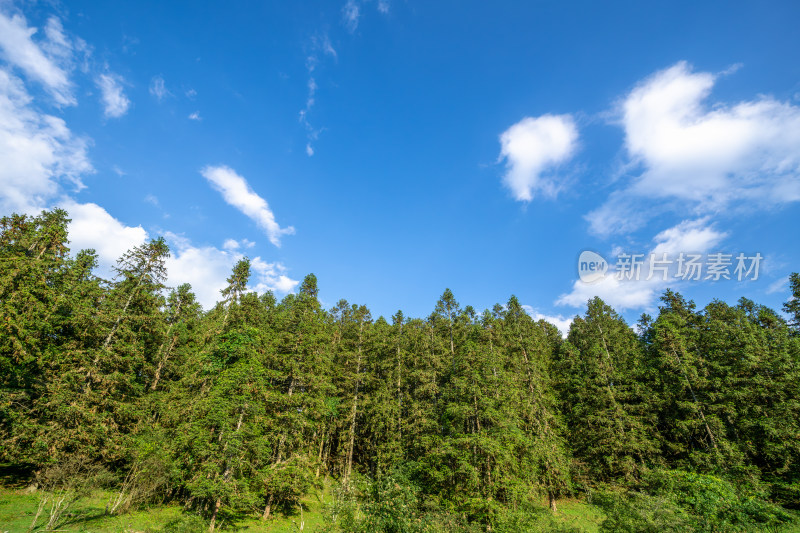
[{"left": 0, "top": 210, "right": 800, "bottom": 532}]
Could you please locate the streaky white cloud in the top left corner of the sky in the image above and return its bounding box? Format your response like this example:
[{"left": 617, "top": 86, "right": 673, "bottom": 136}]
[{"left": 0, "top": 12, "right": 76, "bottom": 105}]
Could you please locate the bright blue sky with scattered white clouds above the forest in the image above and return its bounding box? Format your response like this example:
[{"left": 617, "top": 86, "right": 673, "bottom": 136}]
[{"left": 0, "top": 0, "right": 800, "bottom": 327}]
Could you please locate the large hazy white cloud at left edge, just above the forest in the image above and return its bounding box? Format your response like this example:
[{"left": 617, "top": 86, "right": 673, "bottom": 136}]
[{"left": 0, "top": 68, "right": 93, "bottom": 213}]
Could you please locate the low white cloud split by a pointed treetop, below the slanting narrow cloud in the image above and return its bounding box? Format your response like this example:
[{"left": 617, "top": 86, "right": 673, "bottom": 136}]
[{"left": 165, "top": 232, "right": 299, "bottom": 309}]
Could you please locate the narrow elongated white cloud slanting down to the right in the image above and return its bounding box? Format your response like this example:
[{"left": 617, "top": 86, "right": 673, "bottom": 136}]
[{"left": 200, "top": 166, "right": 294, "bottom": 246}]
